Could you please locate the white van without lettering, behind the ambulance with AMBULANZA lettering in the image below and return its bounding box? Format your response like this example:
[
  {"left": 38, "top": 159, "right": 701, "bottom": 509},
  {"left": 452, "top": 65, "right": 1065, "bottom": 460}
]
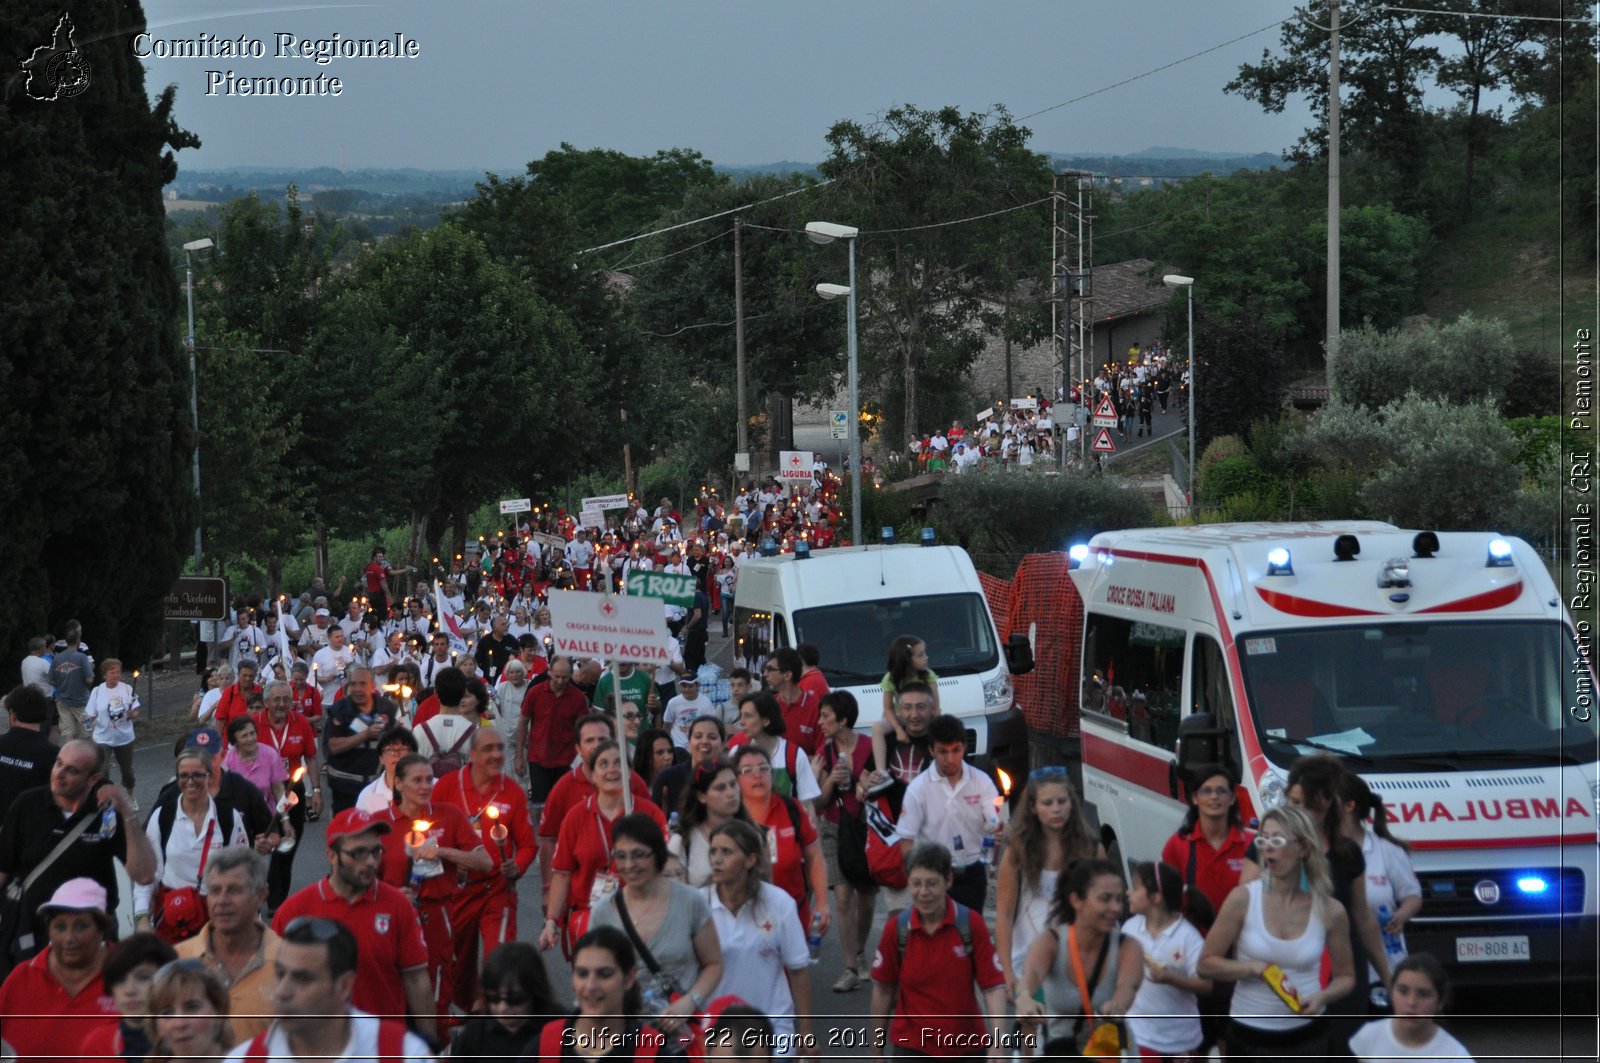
[{"left": 734, "top": 544, "right": 1034, "bottom": 776}]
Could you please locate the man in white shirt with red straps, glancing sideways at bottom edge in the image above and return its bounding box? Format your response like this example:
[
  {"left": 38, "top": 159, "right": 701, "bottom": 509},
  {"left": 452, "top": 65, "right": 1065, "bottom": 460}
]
[{"left": 227, "top": 916, "right": 434, "bottom": 1063}]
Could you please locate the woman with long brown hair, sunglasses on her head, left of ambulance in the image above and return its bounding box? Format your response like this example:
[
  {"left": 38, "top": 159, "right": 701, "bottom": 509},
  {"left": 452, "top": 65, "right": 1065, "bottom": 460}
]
[{"left": 995, "top": 764, "right": 1106, "bottom": 996}]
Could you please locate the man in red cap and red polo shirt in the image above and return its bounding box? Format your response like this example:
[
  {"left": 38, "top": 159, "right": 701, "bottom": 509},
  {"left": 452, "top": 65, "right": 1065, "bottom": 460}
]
[{"left": 272, "top": 808, "right": 437, "bottom": 1037}]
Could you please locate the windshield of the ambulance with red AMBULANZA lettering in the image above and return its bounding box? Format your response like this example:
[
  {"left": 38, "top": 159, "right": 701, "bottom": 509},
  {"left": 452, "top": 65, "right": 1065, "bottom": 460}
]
[{"left": 1238, "top": 621, "right": 1597, "bottom": 770}]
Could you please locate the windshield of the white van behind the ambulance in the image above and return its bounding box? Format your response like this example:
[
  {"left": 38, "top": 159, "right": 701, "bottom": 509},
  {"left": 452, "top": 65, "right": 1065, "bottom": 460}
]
[{"left": 794, "top": 594, "right": 1000, "bottom": 685}]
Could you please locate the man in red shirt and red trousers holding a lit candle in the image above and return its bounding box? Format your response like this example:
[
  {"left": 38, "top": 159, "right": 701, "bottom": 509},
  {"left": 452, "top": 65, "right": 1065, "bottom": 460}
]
[{"left": 434, "top": 727, "right": 539, "bottom": 1012}]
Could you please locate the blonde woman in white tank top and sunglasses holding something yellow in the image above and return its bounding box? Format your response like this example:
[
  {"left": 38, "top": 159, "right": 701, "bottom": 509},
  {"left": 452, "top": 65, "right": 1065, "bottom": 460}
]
[{"left": 1198, "top": 805, "right": 1355, "bottom": 1060}]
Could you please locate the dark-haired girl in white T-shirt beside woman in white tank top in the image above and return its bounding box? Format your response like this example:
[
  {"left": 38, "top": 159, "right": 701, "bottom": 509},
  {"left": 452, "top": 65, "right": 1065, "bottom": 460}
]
[{"left": 1122, "top": 861, "right": 1213, "bottom": 1063}]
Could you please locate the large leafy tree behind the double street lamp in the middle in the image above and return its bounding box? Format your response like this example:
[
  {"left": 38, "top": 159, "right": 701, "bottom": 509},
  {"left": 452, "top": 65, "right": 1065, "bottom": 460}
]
[{"left": 819, "top": 106, "right": 1051, "bottom": 435}]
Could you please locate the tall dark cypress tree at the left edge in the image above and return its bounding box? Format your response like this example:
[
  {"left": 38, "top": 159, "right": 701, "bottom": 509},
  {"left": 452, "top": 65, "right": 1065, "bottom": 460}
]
[{"left": 0, "top": 0, "right": 198, "bottom": 668}]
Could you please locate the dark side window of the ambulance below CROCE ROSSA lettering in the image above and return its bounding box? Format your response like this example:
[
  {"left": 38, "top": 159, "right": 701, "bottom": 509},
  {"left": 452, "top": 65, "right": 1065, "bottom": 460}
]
[{"left": 1080, "top": 613, "right": 1184, "bottom": 749}]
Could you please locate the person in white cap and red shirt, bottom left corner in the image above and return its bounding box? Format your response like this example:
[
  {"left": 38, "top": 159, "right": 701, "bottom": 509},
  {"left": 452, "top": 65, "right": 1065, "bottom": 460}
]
[{"left": 0, "top": 879, "right": 117, "bottom": 1063}]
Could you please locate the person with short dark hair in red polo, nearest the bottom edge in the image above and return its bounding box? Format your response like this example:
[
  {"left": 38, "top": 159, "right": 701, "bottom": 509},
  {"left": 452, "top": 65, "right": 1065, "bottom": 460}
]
[{"left": 872, "top": 844, "right": 1010, "bottom": 1060}]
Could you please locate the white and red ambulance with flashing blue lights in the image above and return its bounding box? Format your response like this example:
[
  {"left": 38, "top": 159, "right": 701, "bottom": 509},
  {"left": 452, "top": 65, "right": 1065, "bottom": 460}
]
[{"left": 1069, "top": 522, "right": 1600, "bottom": 983}]
